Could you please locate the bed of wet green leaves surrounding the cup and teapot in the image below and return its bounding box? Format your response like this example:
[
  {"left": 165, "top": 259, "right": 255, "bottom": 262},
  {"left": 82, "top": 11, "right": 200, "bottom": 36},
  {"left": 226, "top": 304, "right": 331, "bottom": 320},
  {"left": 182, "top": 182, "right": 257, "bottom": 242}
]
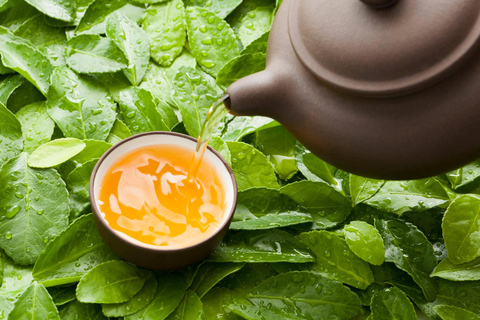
[{"left": 0, "top": 0, "right": 480, "bottom": 320}]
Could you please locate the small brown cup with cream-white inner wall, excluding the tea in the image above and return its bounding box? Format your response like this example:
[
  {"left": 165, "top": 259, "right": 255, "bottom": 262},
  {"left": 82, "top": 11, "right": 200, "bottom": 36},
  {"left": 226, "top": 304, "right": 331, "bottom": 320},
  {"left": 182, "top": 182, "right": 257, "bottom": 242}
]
[{"left": 90, "top": 131, "right": 237, "bottom": 270}]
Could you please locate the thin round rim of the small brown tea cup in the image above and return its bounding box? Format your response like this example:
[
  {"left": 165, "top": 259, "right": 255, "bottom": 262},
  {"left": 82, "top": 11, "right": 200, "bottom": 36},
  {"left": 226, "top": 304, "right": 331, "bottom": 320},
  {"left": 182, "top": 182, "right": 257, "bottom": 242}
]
[{"left": 89, "top": 131, "right": 238, "bottom": 252}]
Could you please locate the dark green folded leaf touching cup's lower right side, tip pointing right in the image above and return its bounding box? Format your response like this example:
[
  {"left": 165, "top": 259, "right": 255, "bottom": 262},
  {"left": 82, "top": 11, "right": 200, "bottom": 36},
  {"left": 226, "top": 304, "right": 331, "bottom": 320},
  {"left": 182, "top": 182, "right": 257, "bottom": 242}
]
[{"left": 230, "top": 187, "right": 313, "bottom": 230}]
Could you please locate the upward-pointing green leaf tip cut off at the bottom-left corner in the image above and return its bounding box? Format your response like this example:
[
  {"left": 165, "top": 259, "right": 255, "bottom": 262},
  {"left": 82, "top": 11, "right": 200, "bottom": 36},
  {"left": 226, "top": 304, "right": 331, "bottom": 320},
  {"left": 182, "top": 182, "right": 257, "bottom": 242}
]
[{"left": 8, "top": 282, "right": 60, "bottom": 320}]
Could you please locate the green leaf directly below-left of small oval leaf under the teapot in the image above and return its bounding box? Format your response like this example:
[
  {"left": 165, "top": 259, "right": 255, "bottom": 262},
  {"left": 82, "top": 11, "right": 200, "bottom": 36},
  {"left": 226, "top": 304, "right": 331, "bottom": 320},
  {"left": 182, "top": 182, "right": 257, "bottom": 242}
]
[{"left": 298, "top": 231, "right": 374, "bottom": 289}]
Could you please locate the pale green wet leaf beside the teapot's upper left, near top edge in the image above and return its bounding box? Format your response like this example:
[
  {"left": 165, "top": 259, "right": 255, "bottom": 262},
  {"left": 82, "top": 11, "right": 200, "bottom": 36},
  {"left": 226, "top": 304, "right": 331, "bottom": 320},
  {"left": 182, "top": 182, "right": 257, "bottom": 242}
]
[{"left": 238, "top": 7, "right": 274, "bottom": 47}]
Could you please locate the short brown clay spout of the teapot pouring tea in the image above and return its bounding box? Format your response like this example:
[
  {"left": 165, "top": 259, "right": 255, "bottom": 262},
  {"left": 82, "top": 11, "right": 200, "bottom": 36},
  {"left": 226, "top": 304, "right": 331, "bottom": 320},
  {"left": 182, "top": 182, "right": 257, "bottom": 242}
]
[{"left": 225, "top": 70, "right": 281, "bottom": 117}]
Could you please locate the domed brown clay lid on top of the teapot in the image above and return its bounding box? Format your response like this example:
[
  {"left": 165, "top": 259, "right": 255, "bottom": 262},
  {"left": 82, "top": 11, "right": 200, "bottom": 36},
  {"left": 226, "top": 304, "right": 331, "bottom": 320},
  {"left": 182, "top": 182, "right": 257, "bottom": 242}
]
[{"left": 289, "top": 0, "right": 480, "bottom": 97}]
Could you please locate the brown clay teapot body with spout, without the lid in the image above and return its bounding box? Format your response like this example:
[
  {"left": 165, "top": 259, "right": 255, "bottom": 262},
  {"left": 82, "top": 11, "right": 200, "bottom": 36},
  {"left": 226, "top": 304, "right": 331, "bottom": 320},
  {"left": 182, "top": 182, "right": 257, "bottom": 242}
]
[{"left": 227, "top": 0, "right": 480, "bottom": 180}]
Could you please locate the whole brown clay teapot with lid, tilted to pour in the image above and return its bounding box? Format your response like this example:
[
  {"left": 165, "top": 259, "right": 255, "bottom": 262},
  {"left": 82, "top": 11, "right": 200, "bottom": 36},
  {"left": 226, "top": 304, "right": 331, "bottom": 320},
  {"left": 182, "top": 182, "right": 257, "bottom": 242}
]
[{"left": 226, "top": 0, "right": 480, "bottom": 179}]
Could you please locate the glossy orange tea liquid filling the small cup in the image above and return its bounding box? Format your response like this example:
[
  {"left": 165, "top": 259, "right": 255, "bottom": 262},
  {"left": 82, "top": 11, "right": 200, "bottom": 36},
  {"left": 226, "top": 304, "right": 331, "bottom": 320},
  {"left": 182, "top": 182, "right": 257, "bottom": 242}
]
[{"left": 99, "top": 145, "right": 226, "bottom": 247}]
